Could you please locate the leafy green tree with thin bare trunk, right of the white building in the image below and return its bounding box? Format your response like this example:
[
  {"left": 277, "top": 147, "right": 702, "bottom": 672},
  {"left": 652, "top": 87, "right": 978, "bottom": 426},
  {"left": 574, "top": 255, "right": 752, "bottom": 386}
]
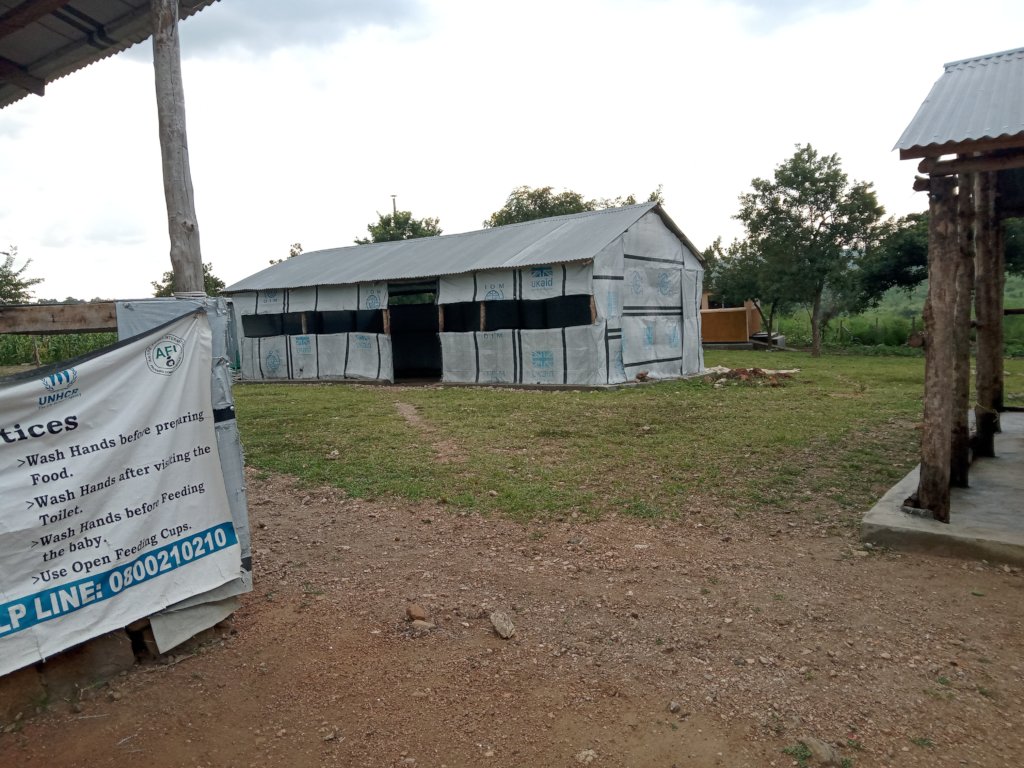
[{"left": 736, "top": 144, "right": 885, "bottom": 356}]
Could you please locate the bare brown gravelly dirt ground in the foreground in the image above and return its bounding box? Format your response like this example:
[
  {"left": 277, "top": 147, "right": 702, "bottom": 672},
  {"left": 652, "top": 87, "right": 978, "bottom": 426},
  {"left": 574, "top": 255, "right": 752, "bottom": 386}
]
[{"left": 0, "top": 473, "right": 1024, "bottom": 768}]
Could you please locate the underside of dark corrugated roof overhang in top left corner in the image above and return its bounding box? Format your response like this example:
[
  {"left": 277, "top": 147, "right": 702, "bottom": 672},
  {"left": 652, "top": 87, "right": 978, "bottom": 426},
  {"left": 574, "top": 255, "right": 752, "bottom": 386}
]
[{"left": 0, "top": 0, "right": 216, "bottom": 109}]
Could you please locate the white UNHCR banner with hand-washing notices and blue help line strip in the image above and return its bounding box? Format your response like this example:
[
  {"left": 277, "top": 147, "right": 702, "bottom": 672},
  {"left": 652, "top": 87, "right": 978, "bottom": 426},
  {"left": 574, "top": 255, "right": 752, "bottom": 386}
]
[{"left": 0, "top": 311, "right": 241, "bottom": 675}]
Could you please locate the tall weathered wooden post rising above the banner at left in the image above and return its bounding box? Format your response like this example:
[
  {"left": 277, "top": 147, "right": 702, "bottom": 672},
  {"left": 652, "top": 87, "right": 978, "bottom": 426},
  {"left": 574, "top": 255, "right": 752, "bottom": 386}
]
[{"left": 150, "top": 0, "right": 206, "bottom": 294}]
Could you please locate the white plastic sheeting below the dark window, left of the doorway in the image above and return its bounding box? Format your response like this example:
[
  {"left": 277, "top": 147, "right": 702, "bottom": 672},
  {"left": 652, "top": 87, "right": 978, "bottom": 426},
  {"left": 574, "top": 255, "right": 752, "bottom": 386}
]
[{"left": 242, "top": 333, "right": 394, "bottom": 381}]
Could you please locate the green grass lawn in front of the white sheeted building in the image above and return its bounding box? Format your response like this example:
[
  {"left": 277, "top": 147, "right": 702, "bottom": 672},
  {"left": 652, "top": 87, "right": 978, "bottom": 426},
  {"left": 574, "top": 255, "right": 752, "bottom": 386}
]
[{"left": 236, "top": 352, "right": 1024, "bottom": 520}]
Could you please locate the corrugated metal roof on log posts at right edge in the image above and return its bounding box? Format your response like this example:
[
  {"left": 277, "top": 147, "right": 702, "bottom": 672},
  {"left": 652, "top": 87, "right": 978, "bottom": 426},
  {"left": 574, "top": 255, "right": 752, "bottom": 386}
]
[{"left": 894, "top": 48, "right": 1024, "bottom": 156}]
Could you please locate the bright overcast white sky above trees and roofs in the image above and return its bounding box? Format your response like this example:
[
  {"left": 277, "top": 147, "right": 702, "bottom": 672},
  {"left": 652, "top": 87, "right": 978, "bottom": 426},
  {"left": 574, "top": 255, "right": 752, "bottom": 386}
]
[{"left": 0, "top": 0, "right": 1024, "bottom": 299}]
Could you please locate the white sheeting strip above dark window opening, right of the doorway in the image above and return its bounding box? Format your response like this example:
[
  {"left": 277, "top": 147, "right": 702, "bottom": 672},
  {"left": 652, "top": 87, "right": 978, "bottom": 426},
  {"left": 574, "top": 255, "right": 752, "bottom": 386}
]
[{"left": 437, "top": 261, "right": 593, "bottom": 304}]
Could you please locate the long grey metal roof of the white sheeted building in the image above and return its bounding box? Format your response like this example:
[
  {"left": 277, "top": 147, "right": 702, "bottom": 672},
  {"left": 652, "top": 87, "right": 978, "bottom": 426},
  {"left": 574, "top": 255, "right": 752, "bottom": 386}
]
[{"left": 223, "top": 203, "right": 700, "bottom": 293}]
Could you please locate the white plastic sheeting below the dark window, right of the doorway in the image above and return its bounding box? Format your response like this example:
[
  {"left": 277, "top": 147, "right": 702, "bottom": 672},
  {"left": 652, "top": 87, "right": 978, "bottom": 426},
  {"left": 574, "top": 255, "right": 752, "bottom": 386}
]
[{"left": 440, "top": 323, "right": 607, "bottom": 386}]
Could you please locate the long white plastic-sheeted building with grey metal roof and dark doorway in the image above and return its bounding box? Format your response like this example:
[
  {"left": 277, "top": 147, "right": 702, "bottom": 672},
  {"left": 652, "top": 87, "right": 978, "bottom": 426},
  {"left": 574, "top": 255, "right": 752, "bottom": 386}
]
[{"left": 224, "top": 203, "right": 703, "bottom": 386}]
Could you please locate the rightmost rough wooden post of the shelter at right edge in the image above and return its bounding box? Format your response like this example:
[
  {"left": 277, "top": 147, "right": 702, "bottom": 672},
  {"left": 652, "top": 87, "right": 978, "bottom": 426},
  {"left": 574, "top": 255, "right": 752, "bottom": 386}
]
[{"left": 975, "top": 173, "right": 1005, "bottom": 457}]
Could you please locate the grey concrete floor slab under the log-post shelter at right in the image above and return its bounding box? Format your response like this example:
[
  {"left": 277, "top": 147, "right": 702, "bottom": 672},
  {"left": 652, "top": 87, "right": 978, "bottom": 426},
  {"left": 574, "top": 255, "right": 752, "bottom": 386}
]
[{"left": 860, "top": 413, "right": 1024, "bottom": 564}]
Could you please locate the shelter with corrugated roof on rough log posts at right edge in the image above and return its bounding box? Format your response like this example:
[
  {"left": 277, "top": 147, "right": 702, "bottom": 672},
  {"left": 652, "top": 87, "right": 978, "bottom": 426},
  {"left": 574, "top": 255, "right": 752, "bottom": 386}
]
[{"left": 895, "top": 48, "right": 1024, "bottom": 522}]
